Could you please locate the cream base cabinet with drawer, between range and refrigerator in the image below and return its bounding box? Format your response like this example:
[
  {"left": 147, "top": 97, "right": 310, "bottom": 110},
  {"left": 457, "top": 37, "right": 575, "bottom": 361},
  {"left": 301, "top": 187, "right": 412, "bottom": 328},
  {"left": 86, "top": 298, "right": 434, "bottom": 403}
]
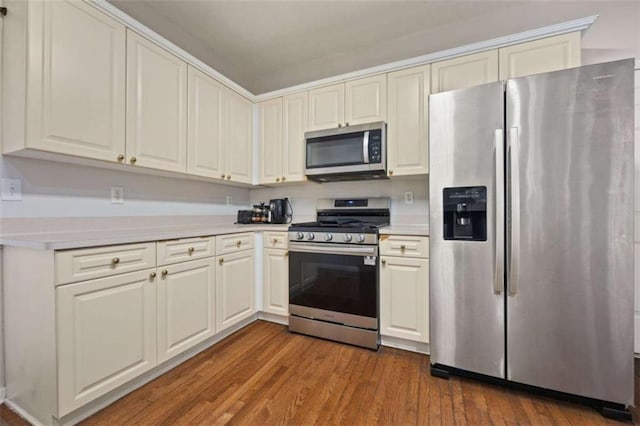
[{"left": 380, "top": 235, "right": 429, "bottom": 343}]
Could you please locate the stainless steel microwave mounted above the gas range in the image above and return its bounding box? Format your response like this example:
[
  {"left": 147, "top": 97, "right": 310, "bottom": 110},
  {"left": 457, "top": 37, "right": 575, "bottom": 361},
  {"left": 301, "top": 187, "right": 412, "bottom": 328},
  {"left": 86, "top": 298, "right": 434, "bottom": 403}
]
[{"left": 304, "top": 121, "right": 387, "bottom": 182}]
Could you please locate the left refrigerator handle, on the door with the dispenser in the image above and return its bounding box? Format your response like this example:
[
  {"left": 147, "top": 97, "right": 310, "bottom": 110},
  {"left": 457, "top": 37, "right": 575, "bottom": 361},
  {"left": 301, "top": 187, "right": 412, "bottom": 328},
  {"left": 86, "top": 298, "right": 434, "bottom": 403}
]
[{"left": 493, "top": 129, "right": 504, "bottom": 294}]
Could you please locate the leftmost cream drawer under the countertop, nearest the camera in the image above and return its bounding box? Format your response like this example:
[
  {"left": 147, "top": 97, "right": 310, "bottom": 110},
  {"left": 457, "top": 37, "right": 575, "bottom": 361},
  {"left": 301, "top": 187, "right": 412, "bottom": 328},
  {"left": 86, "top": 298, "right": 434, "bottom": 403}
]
[{"left": 55, "top": 242, "right": 156, "bottom": 285}]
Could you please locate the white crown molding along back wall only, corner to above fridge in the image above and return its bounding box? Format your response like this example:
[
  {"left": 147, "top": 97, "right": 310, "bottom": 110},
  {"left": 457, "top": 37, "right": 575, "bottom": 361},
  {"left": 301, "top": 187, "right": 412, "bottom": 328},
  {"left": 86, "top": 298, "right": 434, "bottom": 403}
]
[{"left": 255, "top": 15, "right": 598, "bottom": 102}]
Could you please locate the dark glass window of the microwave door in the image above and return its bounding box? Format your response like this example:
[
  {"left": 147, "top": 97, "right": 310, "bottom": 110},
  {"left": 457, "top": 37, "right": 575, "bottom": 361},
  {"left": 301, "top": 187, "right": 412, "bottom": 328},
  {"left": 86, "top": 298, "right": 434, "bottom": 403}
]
[{"left": 307, "top": 132, "right": 364, "bottom": 169}]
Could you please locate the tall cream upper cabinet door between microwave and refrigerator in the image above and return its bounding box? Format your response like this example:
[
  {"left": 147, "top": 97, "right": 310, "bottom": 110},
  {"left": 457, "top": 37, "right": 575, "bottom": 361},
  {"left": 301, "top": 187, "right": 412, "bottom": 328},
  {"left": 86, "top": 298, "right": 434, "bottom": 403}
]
[{"left": 387, "top": 65, "right": 430, "bottom": 176}]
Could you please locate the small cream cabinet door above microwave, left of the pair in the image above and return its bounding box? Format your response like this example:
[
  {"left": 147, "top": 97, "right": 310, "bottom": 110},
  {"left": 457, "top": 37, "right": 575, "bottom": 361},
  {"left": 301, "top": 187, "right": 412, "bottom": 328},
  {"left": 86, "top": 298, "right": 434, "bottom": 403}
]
[{"left": 309, "top": 83, "right": 344, "bottom": 130}]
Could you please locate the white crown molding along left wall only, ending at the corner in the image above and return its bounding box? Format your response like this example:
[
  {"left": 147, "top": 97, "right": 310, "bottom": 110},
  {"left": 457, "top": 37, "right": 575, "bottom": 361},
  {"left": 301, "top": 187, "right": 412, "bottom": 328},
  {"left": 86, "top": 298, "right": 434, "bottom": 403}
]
[{"left": 86, "top": 0, "right": 256, "bottom": 102}]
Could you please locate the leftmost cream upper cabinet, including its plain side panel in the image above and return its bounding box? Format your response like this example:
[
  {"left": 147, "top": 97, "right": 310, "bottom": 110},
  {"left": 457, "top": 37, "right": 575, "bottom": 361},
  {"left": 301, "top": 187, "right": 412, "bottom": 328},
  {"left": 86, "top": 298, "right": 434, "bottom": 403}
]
[{"left": 2, "top": 0, "right": 126, "bottom": 162}]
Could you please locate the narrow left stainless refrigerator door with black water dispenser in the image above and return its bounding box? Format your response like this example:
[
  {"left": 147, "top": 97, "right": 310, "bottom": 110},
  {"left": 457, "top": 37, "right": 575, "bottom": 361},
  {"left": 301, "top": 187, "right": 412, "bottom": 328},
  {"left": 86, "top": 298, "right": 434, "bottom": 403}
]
[{"left": 429, "top": 83, "right": 505, "bottom": 378}]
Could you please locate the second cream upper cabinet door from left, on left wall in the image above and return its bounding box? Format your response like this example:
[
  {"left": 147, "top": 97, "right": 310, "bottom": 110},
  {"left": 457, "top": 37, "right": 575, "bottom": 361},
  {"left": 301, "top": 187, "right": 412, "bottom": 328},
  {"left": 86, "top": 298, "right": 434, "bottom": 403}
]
[{"left": 127, "top": 31, "right": 187, "bottom": 172}]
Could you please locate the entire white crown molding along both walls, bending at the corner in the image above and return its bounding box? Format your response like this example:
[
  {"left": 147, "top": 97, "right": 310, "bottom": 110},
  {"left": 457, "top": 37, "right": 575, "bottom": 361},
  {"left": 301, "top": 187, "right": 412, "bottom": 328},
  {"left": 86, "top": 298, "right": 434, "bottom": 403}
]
[{"left": 86, "top": 0, "right": 598, "bottom": 103}]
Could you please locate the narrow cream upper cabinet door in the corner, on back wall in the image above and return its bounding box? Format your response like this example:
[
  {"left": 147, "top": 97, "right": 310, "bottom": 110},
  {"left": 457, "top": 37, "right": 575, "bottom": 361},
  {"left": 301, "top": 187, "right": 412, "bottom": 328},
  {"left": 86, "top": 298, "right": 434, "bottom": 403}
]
[{"left": 259, "top": 98, "right": 282, "bottom": 184}]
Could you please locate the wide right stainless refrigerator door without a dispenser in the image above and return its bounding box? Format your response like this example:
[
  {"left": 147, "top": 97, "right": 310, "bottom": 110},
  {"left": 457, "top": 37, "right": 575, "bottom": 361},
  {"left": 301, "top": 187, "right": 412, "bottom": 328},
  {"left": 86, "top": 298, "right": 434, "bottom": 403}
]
[{"left": 506, "top": 60, "right": 634, "bottom": 404}]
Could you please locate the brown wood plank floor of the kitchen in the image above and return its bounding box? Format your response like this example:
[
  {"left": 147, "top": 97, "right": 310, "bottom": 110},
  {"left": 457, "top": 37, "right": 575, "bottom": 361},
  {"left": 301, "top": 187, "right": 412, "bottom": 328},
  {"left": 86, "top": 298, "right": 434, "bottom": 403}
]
[{"left": 0, "top": 321, "right": 640, "bottom": 425}]
